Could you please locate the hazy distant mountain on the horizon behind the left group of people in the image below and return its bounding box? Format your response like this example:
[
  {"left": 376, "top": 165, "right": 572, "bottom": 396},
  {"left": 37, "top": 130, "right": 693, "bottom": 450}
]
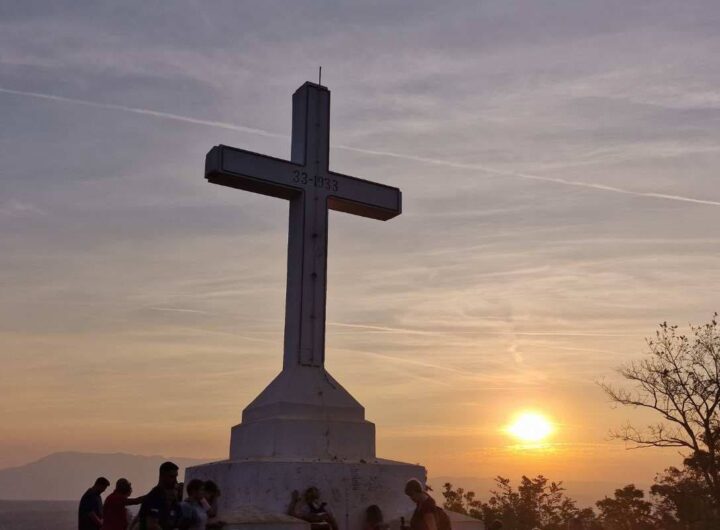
[{"left": 0, "top": 452, "right": 213, "bottom": 501}]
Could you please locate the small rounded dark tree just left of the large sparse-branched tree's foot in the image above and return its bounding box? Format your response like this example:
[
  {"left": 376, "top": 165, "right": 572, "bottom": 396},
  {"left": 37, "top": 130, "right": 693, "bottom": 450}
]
[{"left": 595, "top": 484, "right": 657, "bottom": 530}]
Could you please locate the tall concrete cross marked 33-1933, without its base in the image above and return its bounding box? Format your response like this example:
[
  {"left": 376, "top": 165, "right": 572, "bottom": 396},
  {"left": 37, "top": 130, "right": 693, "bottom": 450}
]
[{"left": 205, "top": 82, "right": 401, "bottom": 369}]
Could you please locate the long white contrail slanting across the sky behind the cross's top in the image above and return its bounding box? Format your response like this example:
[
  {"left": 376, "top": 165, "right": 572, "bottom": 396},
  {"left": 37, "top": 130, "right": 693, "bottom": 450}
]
[{"left": 0, "top": 88, "right": 720, "bottom": 206}]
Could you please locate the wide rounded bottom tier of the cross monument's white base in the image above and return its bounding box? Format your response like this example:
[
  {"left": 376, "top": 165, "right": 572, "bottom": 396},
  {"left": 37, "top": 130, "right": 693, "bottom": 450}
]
[{"left": 185, "top": 458, "right": 428, "bottom": 530}]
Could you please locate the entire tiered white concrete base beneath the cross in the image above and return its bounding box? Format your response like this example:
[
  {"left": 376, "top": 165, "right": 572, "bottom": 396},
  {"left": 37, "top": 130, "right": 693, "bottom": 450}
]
[{"left": 191, "top": 366, "right": 424, "bottom": 530}]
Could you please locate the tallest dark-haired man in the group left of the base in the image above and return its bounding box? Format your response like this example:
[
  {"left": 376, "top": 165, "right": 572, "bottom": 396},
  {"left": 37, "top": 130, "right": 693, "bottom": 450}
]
[{"left": 138, "top": 462, "right": 181, "bottom": 530}]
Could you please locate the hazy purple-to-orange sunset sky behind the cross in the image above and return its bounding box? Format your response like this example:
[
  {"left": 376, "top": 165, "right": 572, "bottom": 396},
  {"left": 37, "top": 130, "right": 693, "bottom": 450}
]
[{"left": 0, "top": 0, "right": 720, "bottom": 502}]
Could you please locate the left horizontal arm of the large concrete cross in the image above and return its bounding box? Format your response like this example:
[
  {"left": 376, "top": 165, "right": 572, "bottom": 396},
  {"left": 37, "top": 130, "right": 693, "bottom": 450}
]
[{"left": 205, "top": 145, "right": 302, "bottom": 199}]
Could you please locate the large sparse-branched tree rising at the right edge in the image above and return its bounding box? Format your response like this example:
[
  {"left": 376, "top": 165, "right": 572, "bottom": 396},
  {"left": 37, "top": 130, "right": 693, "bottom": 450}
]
[{"left": 601, "top": 313, "right": 720, "bottom": 507}]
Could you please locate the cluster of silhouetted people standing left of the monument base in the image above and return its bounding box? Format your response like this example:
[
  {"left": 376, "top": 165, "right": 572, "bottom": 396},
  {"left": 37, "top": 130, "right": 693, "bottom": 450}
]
[{"left": 78, "top": 462, "right": 223, "bottom": 530}]
